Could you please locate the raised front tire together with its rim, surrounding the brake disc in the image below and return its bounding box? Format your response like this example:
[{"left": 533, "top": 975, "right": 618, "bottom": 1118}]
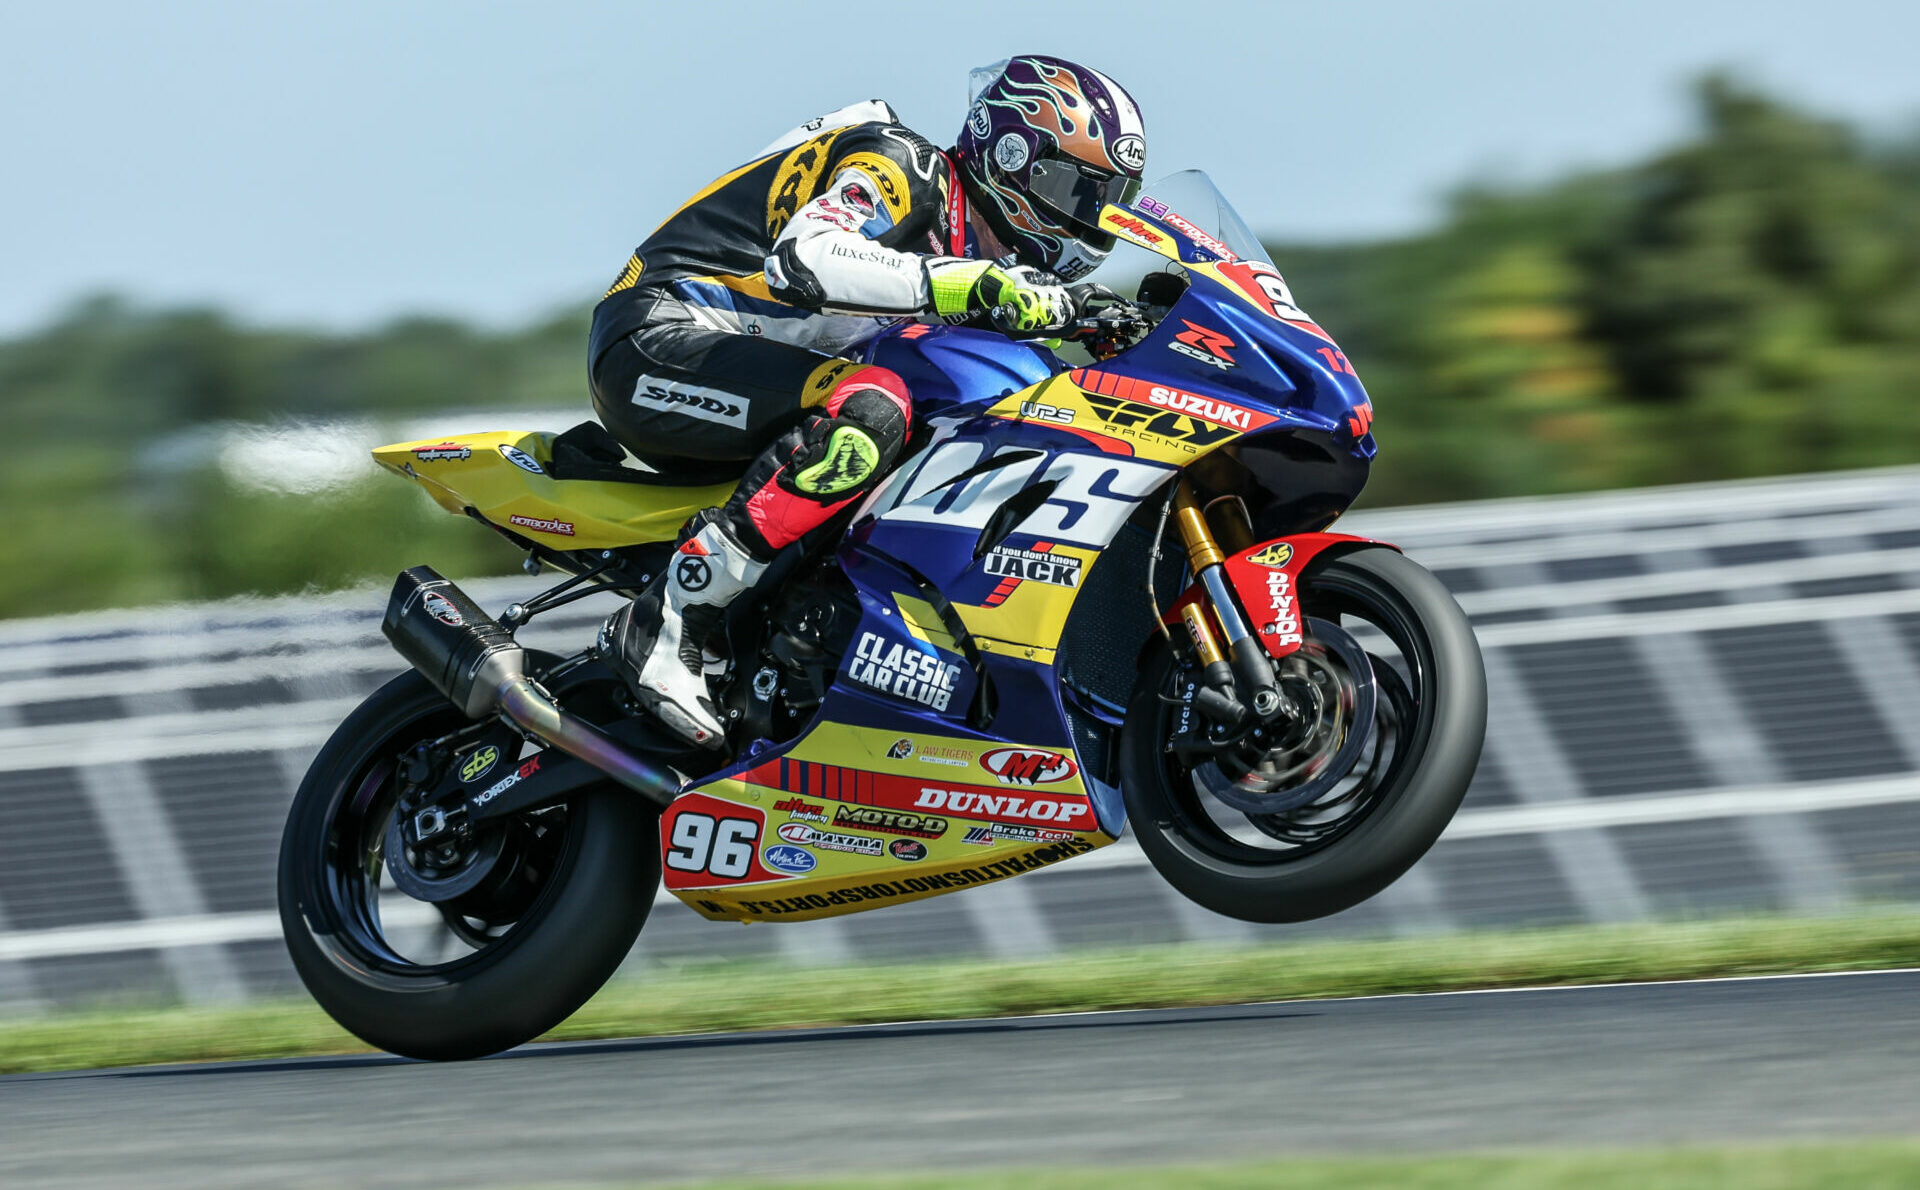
[{"left": 1119, "top": 547, "right": 1486, "bottom": 921}]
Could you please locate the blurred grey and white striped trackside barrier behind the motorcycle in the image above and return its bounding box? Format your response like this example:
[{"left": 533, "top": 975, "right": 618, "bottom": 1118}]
[{"left": 0, "top": 468, "right": 1920, "bottom": 1012}]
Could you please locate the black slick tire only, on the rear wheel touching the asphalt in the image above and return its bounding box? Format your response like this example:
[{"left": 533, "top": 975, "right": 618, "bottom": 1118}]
[{"left": 278, "top": 658, "right": 660, "bottom": 1061}]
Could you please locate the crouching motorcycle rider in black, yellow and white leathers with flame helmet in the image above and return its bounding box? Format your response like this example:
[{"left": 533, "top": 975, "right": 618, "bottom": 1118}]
[{"left": 589, "top": 56, "right": 1146, "bottom": 749}]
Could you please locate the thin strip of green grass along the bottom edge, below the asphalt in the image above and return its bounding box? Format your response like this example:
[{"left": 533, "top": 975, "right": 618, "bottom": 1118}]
[{"left": 652, "top": 1142, "right": 1920, "bottom": 1190}]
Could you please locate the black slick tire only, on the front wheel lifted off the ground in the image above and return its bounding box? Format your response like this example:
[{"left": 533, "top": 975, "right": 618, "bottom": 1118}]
[{"left": 1119, "top": 547, "right": 1486, "bottom": 921}]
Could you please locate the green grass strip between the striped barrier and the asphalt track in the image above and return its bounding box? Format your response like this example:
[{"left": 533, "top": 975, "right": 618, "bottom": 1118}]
[{"left": 0, "top": 912, "right": 1920, "bottom": 1073}]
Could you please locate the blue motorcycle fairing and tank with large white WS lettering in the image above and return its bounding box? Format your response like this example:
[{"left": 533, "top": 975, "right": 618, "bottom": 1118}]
[{"left": 706, "top": 249, "right": 1375, "bottom": 835}]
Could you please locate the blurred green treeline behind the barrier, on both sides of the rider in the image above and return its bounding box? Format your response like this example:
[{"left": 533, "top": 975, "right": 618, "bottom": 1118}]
[{"left": 0, "top": 75, "right": 1920, "bottom": 614}]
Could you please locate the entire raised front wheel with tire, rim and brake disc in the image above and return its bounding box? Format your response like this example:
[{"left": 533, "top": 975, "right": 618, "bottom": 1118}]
[{"left": 1119, "top": 547, "right": 1486, "bottom": 921}]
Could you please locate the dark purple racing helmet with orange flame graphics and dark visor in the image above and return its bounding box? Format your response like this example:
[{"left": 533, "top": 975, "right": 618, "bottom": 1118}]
[{"left": 954, "top": 54, "right": 1146, "bottom": 280}]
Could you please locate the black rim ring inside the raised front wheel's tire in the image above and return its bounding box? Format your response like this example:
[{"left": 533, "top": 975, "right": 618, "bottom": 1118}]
[{"left": 1152, "top": 566, "right": 1434, "bottom": 868}]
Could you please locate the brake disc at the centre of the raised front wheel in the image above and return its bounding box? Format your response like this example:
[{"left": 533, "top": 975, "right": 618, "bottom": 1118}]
[{"left": 1192, "top": 616, "right": 1379, "bottom": 816}]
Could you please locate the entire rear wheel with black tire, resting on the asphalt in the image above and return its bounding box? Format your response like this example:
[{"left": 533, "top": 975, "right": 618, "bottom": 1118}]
[{"left": 280, "top": 658, "right": 660, "bottom": 1059}]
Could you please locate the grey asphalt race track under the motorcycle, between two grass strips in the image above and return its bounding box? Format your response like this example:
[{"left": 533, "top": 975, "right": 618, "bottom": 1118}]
[{"left": 0, "top": 971, "right": 1920, "bottom": 1190}]
